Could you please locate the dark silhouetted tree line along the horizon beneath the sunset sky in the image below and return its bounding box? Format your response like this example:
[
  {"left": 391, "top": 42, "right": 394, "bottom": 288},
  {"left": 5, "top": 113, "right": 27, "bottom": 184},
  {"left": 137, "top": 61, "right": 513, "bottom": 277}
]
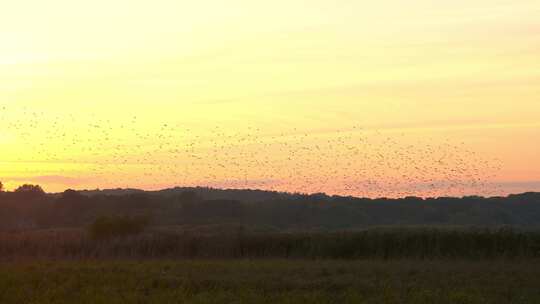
[{"left": 0, "top": 185, "right": 540, "bottom": 232}]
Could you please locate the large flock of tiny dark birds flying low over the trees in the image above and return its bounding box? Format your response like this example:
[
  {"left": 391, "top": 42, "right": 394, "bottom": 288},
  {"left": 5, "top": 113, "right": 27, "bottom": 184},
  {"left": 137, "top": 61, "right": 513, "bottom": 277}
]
[{"left": 0, "top": 105, "right": 502, "bottom": 197}]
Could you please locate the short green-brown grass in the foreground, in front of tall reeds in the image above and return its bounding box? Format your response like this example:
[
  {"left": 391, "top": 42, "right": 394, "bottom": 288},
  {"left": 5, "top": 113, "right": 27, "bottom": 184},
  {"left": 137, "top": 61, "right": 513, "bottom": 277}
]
[{"left": 0, "top": 259, "right": 540, "bottom": 304}]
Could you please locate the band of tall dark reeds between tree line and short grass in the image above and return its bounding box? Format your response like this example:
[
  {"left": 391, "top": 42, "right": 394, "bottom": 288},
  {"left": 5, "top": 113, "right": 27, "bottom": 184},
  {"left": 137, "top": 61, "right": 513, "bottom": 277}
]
[{"left": 0, "top": 228, "right": 540, "bottom": 259}]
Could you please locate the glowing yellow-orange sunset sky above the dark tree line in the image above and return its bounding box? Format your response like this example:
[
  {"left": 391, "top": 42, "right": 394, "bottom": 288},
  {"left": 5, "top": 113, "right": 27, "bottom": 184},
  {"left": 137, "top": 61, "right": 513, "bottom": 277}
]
[{"left": 0, "top": 0, "right": 540, "bottom": 197}]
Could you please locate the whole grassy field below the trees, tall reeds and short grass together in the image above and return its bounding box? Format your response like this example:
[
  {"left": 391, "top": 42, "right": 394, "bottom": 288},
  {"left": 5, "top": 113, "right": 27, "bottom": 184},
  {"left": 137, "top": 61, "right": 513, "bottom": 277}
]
[{"left": 0, "top": 225, "right": 540, "bottom": 304}]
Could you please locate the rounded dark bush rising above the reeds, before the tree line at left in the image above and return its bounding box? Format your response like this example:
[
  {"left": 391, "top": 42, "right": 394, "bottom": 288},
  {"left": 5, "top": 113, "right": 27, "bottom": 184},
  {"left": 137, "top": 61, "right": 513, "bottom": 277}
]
[{"left": 88, "top": 216, "right": 149, "bottom": 240}]
